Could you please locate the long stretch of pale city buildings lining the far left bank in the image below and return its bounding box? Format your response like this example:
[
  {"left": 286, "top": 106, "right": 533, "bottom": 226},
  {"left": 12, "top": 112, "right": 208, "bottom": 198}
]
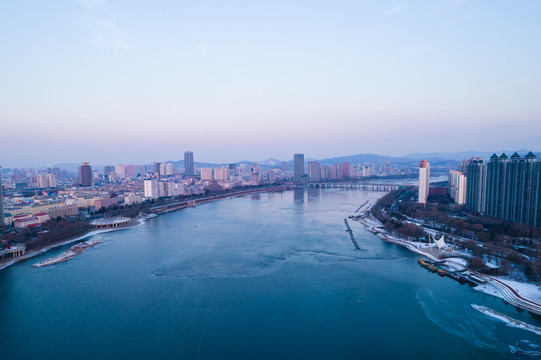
[{"left": 0, "top": 151, "right": 426, "bottom": 230}]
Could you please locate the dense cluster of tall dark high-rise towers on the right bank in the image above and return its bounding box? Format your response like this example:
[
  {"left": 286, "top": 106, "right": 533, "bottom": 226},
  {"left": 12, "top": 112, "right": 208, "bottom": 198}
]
[{"left": 449, "top": 152, "right": 541, "bottom": 227}]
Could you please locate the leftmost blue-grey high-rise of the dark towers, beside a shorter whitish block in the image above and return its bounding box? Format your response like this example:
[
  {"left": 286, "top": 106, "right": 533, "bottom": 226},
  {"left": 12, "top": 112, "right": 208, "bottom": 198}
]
[{"left": 463, "top": 157, "right": 487, "bottom": 213}]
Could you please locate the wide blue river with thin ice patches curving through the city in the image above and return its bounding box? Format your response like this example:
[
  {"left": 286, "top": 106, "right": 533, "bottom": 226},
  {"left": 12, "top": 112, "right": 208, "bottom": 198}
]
[{"left": 0, "top": 189, "right": 541, "bottom": 359}]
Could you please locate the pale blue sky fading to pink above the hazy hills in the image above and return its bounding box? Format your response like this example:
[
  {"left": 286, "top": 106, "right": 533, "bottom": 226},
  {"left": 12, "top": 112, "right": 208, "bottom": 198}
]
[{"left": 0, "top": 0, "right": 541, "bottom": 167}]
